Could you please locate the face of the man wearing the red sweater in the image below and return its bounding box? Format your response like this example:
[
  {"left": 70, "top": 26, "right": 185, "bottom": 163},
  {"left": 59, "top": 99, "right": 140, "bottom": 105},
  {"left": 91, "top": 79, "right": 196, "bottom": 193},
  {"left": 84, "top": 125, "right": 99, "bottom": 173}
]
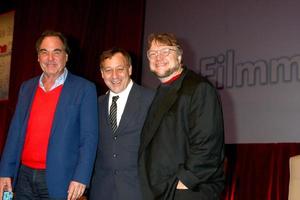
[{"left": 38, "top": 36, "right": 68, "bottom": 79}]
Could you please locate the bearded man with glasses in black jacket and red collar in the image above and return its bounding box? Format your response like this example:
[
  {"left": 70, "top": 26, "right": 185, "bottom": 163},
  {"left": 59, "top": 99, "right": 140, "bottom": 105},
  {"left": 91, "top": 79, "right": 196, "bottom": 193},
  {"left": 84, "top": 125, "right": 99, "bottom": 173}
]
[{"left": 139, "top": 33, "right": 224, "bottom": 200}]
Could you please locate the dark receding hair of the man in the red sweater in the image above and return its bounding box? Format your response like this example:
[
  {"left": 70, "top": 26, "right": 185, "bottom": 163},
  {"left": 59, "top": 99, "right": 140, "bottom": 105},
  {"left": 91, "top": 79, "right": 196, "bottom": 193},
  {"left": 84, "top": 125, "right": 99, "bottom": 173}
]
[{"left": 35, "top": 30, "right": 70, "bottom": 54}]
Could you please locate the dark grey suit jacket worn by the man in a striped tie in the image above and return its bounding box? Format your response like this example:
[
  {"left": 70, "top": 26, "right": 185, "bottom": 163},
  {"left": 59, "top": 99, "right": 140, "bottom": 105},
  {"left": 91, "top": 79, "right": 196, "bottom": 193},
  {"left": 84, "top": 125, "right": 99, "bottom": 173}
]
[{"left": 89, "top": 83, "right": 154, "bottom": 200}]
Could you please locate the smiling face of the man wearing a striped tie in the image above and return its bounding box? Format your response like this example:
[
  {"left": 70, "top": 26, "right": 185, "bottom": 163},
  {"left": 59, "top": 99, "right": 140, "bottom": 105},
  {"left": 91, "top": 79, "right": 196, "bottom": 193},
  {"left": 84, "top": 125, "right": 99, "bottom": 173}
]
[{"left": 101, "top": 53, "right": 132, "bottom": 94}]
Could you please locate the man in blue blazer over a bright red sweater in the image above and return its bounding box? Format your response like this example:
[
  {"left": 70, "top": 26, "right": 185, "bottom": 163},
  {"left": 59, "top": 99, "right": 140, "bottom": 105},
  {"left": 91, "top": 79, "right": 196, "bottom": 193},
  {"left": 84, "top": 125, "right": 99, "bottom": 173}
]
[{"left": 0, "top": 31, "right": 98, "bottom": 200}]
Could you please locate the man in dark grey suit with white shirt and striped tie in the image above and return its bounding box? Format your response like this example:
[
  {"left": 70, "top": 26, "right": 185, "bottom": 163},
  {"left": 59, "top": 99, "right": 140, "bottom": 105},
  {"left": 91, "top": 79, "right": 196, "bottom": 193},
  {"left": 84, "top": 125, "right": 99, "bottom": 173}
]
[{"left": 89, "top": 48, "right": 154, "bottom": 200}]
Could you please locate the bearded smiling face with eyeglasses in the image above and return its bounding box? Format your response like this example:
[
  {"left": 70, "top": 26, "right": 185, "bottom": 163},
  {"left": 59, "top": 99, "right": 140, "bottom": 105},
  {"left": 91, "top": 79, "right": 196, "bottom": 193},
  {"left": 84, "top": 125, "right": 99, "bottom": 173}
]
[{"left": 147, "top": 41, "right": 182, "bottom": 82}]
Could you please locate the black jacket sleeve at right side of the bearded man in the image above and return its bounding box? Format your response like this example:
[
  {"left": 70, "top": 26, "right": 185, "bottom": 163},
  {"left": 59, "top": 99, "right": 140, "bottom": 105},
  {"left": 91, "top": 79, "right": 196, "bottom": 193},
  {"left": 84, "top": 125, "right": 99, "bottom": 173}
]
[{"left": 177, "top": 83, "right": 224, "bottom": 189}]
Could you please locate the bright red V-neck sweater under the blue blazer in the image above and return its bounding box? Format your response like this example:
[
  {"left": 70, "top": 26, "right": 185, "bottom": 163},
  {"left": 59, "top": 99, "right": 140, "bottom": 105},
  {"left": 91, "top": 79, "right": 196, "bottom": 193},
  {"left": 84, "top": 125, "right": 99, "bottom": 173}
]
[{"left": 22, "top": 85, "right": 62, "bottom": 169}]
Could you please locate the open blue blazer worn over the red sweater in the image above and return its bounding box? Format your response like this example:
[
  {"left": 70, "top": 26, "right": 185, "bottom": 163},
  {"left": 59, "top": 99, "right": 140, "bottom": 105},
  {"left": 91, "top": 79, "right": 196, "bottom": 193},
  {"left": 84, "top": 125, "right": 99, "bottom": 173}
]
[{"left": 0, "top": 72, "right": 98, "bottom": 198}]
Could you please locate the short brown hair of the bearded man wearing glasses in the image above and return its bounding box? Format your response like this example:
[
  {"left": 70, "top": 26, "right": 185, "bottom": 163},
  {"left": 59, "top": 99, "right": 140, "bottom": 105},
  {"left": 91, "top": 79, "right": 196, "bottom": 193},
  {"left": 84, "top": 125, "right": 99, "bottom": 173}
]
[{"left": 148, "top": 33, "right": 182, "bottom": 54}]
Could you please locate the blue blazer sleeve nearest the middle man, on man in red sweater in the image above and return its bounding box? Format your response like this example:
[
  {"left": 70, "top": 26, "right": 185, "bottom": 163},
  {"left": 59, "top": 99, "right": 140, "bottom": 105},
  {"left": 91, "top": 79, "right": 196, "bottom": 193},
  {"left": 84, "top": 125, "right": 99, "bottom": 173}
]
[{"left": 73, "top": 84, "right": 99, "bottom": 185}]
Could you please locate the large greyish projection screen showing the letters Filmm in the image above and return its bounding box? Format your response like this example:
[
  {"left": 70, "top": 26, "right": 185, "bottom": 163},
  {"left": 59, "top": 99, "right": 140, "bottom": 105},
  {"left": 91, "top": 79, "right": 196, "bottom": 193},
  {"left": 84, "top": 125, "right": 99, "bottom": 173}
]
[{"left": 142, "top": 0, "right": 300, "bottom": 144}]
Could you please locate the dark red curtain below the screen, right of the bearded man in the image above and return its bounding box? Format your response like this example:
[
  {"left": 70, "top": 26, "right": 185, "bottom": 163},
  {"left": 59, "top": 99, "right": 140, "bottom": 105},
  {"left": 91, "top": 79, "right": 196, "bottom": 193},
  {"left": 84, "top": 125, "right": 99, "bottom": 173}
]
[{"left": 223, "top": 143, "right": 300, "bottom": 200}]
